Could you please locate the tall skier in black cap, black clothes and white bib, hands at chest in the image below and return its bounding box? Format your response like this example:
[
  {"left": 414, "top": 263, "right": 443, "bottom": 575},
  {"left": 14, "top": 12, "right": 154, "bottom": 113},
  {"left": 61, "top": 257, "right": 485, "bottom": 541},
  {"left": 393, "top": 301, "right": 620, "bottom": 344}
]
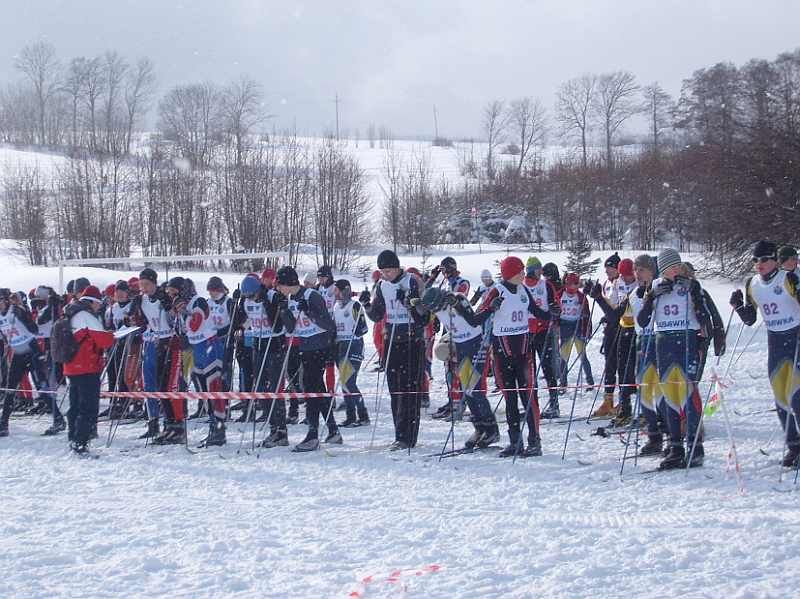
[{"left": 359, "top": 250, "right": 425, "bottom": 450}]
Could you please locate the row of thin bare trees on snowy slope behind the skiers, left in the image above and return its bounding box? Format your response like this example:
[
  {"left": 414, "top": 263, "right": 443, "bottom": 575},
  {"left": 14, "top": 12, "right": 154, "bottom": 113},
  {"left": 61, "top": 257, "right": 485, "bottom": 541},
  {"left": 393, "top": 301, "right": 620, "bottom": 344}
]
[{"left": 0, "top": 136, "right": 370, "bottom": 268}]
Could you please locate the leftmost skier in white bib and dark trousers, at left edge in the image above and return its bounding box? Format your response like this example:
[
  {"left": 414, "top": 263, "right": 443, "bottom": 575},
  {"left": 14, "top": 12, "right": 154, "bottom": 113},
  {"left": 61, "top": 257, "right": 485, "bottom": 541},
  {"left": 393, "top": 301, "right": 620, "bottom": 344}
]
[{"left": 0, "top": 289, "right": 66, "bottom": 437}]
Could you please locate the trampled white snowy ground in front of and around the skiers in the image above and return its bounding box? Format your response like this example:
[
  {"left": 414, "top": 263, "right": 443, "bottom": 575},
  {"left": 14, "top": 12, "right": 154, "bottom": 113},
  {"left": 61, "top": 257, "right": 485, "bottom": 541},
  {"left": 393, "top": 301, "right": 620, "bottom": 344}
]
[{"left": 0, "top": 248, "right": 800, "bottom": 597}]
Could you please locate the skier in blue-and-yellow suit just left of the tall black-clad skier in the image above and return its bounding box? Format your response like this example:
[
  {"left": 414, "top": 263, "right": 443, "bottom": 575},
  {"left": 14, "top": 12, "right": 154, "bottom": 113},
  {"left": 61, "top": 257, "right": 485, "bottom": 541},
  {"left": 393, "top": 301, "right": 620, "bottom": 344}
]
[{"left": 333, "top": 279, "right": 369, "bottom": 428}]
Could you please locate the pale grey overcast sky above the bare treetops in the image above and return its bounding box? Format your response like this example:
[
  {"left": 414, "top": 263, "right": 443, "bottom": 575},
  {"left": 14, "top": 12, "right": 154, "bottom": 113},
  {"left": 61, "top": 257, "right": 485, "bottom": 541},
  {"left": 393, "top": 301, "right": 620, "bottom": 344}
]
[{"left": 0, "top": 0, "right": 800, "bottom": 137}]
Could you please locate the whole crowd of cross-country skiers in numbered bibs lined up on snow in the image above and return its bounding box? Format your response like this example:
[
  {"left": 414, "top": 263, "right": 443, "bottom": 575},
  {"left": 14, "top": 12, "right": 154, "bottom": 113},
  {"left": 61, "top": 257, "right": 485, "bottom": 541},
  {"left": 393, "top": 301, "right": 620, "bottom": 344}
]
[{"left": 0, "top": 241, "right": 800, "bottom": 469}]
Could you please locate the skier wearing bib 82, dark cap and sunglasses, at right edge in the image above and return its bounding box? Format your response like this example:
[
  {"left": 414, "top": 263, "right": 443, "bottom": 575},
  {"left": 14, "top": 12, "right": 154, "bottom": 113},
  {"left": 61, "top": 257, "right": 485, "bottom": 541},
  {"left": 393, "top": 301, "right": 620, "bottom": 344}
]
[{"left": 730, "top": 241, "right": 800, "bottom": 468}]
